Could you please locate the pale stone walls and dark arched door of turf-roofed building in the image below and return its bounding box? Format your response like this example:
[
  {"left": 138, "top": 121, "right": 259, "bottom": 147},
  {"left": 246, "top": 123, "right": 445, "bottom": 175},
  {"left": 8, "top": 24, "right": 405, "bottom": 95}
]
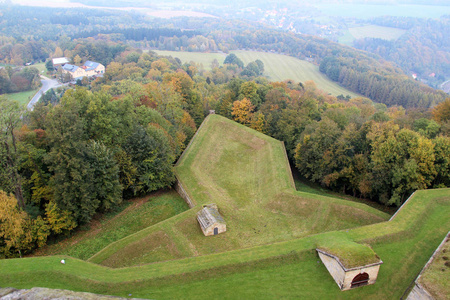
[{"left": 316, "top": 249, "right": 383, "bottom": 291}]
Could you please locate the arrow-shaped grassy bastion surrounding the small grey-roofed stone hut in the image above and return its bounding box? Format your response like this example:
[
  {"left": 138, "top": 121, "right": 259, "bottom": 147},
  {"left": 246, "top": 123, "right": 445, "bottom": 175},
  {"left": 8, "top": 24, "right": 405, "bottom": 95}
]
[{"left": 89, "top": 115, "right": 388, "bottom": 267}]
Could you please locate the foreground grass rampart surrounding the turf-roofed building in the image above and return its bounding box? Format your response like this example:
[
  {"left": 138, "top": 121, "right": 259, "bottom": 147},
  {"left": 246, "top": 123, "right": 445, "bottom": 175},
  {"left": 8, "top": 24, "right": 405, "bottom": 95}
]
[{"left": 0, "top": 189, "right": 450, "bottom": 299}]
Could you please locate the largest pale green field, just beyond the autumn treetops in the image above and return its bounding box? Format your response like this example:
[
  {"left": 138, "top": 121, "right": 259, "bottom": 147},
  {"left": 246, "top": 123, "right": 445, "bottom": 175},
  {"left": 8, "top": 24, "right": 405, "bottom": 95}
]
[{"left": 155, "top": 50, "right": 359, "bottom": 97}]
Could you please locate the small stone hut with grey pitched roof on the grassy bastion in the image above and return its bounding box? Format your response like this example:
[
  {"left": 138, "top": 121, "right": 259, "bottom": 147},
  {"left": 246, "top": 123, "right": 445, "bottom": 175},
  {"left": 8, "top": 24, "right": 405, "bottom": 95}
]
[{"left": 197, "top": 204, "right": 227, "bottom": 236}]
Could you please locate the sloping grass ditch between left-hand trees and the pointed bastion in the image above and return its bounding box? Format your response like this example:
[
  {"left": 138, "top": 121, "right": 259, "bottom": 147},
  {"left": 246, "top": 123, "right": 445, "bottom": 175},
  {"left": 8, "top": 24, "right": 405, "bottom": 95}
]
[{"left": 34, "top": 190, "right": 189, "bottom": 259}]
